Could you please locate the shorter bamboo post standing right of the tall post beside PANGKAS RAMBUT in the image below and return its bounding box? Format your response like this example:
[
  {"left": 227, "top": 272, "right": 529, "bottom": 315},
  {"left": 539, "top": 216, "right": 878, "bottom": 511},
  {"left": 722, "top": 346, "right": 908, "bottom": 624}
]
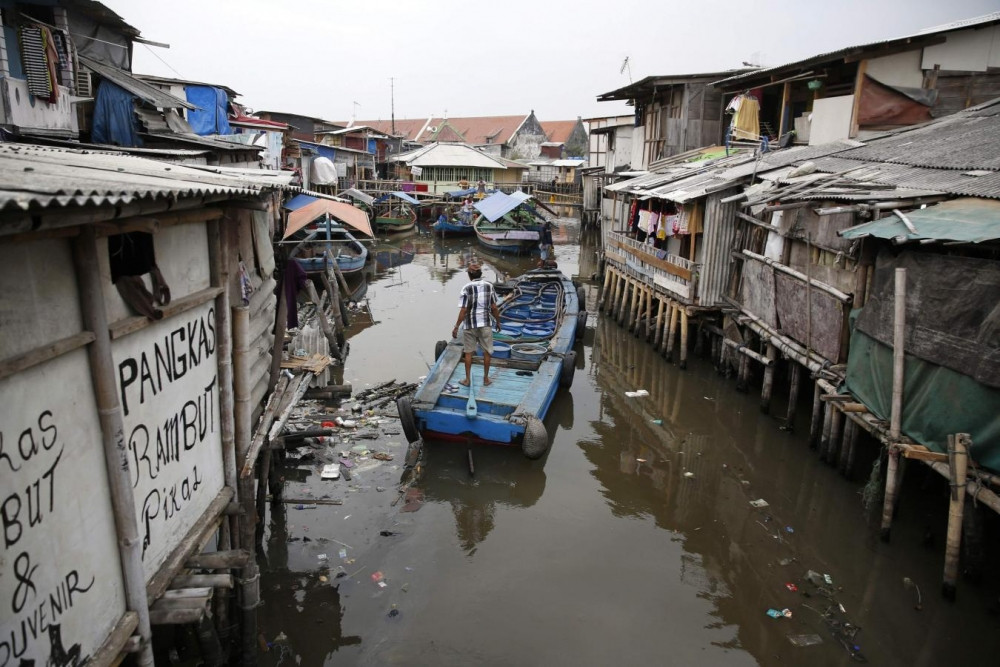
[{"left": 232, "top": 307, "right": 260, "bottom": 666}]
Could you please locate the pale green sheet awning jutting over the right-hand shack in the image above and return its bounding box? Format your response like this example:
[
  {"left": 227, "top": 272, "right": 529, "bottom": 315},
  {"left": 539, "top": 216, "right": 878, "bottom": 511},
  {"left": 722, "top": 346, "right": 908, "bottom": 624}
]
[{"left": 840, "top": 199, "right": 1000, "bottom": 243}]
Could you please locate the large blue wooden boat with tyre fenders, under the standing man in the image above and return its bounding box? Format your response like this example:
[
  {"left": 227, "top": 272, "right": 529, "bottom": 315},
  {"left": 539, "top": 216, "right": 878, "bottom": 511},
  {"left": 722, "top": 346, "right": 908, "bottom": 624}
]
[{"left": 397, "top": 269, "right": 587, "bottom": 458}]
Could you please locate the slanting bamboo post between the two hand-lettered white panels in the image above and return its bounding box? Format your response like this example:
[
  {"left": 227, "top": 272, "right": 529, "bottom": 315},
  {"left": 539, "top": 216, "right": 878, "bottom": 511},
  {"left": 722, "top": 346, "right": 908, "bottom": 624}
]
[{"left": 72, "top": 231, "right": 153, "bottom": 667}]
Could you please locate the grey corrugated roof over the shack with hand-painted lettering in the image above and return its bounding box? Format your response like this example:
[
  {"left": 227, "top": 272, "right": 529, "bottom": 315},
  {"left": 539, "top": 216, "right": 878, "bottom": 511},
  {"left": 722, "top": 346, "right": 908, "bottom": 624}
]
[{"left": 0, "top": 144, "right": 293, "bottom": 211}]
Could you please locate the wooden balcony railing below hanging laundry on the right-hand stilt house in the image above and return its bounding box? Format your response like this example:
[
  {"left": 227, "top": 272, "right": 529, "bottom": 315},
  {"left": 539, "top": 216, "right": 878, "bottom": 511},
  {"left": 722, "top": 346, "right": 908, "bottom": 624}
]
[{"left": 604, "top": 232, "right": 700, "bottom": 303}]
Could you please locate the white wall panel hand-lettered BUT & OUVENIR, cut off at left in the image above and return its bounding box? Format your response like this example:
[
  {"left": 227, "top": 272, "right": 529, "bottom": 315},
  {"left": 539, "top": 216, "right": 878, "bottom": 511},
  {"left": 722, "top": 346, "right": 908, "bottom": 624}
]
[{"left": 0, "top": 350, "right": 125, "bottom": 667}]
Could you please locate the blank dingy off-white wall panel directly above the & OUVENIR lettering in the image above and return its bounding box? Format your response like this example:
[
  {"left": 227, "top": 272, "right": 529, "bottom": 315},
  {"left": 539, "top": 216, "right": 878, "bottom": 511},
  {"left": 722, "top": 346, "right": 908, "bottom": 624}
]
[{"left": 0, "top": 239, "right": 83, "bottom": 359}]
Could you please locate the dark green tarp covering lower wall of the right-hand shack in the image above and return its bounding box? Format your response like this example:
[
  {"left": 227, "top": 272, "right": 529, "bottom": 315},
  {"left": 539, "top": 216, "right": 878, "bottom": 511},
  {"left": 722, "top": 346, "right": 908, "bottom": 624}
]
[{"left": 847, "top": 330, "right": 1000, "bottom": 472}]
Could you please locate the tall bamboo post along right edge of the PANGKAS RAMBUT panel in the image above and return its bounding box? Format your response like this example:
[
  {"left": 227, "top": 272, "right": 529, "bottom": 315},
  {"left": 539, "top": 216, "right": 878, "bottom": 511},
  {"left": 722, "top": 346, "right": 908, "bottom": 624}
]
[{"left": 208, "top": 220, "right": 236, "bottom": 646}]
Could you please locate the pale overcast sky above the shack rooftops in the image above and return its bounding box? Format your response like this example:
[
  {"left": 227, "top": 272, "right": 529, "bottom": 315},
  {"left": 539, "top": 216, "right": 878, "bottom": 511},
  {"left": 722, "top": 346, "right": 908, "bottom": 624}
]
[{"left": 103, "top": 0, "right": 1000, "bottom": 121}]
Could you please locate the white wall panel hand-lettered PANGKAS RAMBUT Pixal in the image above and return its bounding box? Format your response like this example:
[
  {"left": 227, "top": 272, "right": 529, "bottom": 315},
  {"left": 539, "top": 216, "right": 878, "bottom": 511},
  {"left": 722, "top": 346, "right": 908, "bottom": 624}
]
[{"left": 112, "top": 304, "right": 223, "bottom": 581}]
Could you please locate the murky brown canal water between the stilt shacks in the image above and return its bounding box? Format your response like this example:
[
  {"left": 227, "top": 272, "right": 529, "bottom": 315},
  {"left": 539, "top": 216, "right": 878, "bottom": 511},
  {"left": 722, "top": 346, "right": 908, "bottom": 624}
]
[{"left": 260, "top": 222, "right": 1000, "bottom": 665}]
